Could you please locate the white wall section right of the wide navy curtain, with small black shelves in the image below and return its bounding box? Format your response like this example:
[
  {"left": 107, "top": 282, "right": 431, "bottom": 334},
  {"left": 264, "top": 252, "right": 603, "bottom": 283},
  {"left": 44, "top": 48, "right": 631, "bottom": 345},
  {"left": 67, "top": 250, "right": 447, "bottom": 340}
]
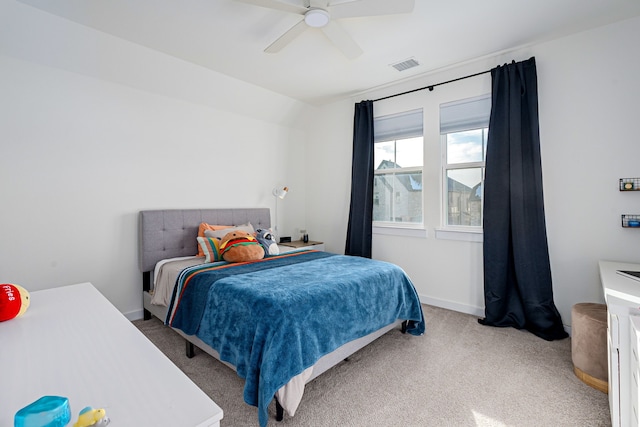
[{"left": 535, "top": 18, "right": 640, "bottom": 323}]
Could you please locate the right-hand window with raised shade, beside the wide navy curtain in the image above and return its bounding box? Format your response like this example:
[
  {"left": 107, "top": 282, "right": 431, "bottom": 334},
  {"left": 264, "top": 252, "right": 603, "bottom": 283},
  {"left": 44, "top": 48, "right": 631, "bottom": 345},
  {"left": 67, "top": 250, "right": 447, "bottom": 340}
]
[{"left": 440, "top": 95, "right": 491, "bottom": 231}]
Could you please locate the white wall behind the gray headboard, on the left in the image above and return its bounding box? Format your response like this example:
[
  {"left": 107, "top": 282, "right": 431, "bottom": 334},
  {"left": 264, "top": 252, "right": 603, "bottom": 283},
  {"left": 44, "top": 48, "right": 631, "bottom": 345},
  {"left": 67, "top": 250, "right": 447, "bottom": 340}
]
[{"left": 0, "top": 2, "right": 309, "bottom": 318}]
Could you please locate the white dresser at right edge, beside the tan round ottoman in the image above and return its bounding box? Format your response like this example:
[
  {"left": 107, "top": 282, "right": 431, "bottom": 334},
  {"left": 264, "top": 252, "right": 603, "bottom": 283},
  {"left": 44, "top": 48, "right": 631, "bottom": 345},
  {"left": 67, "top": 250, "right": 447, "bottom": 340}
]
[{"left": 599, "top": 261, "right": 640, "bottom": 427}]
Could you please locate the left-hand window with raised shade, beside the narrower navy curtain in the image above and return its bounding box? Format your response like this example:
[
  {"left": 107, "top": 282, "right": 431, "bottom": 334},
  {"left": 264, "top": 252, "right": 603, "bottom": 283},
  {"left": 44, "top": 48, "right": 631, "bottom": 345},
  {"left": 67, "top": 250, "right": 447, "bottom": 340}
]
[{"left": 373, "top": 109, "right": 424, "bottom": 226}]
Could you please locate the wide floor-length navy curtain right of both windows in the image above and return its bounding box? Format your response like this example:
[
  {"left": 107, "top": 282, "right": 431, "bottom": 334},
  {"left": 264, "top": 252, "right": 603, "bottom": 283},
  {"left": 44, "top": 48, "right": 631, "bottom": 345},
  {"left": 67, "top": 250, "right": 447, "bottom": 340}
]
[{"left": 479, "top": 58, "right": 568, "bottom": 340}]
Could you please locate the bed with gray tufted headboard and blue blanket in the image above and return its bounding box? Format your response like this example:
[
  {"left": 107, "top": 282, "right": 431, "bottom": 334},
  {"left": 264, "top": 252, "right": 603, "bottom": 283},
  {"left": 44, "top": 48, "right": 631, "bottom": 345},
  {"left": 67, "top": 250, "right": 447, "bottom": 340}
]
[{"left": 139, "top": 208, "right": 424, "bottom": 426}]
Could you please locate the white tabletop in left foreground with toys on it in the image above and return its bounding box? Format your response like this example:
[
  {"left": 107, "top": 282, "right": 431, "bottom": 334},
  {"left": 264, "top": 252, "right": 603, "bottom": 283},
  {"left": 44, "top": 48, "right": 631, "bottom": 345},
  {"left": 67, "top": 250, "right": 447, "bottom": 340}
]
[{"left": 0, "top": 283, "right": 223, "bottom": 427}]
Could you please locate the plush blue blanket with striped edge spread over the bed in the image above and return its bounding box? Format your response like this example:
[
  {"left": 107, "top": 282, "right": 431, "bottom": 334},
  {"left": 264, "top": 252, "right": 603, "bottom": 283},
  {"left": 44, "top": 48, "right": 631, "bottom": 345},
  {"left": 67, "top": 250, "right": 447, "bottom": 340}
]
[{"left": 166, "top": 251, "right": 425, "bottom": 427}]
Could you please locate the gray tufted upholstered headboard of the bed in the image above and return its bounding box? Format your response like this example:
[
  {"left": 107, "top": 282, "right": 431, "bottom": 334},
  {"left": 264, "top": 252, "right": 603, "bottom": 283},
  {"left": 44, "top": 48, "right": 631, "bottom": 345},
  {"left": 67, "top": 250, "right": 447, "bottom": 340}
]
[{"left": 138, "top": 208, "right": 271, "bottom": 273}]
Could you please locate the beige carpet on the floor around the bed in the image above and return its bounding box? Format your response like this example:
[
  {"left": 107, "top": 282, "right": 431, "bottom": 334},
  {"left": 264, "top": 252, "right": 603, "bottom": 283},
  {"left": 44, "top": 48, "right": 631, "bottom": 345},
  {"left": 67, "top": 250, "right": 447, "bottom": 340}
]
[{"left": 133, "top": 306, "right": 611, "bottom": 427}]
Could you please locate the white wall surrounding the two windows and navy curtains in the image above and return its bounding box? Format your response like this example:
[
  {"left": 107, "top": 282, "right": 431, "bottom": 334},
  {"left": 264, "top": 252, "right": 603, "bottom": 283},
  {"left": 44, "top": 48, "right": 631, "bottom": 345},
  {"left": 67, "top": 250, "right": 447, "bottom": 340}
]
[{"left": 306, "top": 18, "right": 640, "bottom": 325}]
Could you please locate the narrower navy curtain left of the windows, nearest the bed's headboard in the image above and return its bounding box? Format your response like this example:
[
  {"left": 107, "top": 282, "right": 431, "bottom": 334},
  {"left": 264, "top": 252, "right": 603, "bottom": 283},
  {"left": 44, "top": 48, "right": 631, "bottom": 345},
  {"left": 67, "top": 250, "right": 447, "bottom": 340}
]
[{"left": 344, "top": 101, "right": 373, "bottom": 258}]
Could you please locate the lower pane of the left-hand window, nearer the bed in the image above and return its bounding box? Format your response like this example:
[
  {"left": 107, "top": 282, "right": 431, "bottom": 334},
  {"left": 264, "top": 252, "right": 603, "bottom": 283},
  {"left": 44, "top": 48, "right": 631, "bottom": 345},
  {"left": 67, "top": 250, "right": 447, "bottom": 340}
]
[{"left": 373, "top": 172, "right": 422, "bottom": 223}]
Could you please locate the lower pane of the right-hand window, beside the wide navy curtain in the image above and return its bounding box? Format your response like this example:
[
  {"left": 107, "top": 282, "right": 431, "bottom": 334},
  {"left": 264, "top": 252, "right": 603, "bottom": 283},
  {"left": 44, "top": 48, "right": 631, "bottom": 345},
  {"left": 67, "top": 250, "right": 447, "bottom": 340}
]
[{"left": 447, "top": 168, "right": 482, "bottom": 226}]
